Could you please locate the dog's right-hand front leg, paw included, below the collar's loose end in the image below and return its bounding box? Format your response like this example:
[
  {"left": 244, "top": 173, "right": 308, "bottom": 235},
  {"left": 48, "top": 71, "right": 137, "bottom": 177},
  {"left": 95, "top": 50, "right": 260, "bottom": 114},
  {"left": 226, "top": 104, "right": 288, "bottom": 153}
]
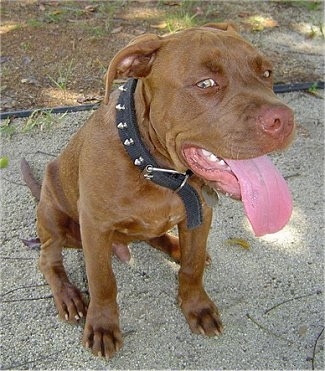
[{"left": 178, "top": 207, "right": 222, "bottom": 336}]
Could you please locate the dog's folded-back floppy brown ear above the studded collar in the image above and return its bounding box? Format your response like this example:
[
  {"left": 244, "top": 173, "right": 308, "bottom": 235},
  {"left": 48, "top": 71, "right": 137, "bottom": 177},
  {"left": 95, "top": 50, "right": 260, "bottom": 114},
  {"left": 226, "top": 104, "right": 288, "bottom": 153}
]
[{"left": 104, "top": 34, "right": 162, "bottom": 104}]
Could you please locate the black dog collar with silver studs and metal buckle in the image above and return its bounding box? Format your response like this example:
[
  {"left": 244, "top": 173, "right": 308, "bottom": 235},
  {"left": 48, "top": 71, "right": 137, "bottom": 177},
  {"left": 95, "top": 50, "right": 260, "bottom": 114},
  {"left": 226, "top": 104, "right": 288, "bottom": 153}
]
[{"left": 115, "top": 79, "right": 202, "bottom": 229}]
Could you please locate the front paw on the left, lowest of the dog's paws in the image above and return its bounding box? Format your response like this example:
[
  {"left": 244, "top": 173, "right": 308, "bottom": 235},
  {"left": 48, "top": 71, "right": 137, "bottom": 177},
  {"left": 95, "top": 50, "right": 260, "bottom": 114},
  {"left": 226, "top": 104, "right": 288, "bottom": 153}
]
[{"left": 82, "top": 309, "right": 123, "bottom": 359}]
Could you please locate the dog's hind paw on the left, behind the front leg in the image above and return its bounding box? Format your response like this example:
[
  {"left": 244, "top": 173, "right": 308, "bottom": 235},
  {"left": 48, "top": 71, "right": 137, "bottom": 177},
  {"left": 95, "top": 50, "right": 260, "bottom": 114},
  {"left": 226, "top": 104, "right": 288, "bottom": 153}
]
[{"left": 54, "top": 283, "right": 87, "bottom": 323}]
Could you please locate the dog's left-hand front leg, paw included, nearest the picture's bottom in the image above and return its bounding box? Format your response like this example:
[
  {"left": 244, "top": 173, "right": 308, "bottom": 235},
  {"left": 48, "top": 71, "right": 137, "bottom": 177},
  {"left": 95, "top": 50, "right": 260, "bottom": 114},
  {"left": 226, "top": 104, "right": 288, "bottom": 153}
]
[{"left": 80, "top": 212, "right": 122, "bottom": 358}]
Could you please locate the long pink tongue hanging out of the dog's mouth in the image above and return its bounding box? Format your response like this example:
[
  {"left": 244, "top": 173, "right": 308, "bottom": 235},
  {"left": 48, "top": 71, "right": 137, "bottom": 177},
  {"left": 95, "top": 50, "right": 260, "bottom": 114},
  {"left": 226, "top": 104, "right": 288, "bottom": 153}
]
[{"left": 225, "top": 156, "right": 292, "bottom": 236}]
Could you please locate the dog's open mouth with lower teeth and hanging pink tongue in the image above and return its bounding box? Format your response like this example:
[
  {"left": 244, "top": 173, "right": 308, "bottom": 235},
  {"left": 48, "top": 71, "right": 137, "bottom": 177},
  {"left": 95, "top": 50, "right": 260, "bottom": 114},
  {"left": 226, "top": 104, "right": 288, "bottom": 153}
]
[{"left": 183, "top": 147, "right": 292, "bottom": 236}]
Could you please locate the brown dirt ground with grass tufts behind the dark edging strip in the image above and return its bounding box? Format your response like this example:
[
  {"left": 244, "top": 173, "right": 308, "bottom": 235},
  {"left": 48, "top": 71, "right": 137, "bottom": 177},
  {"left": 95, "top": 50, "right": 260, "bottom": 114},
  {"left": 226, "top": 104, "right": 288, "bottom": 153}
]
[{"left": 1, "top": 0, "right": 324, "bottom": 111}]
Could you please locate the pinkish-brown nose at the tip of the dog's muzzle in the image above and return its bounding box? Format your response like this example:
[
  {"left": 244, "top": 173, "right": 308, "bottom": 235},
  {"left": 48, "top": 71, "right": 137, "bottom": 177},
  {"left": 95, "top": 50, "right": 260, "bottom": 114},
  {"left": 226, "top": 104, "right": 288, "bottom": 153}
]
[{"left": 257, "top": 105, "right": 294, "bottom": 139}]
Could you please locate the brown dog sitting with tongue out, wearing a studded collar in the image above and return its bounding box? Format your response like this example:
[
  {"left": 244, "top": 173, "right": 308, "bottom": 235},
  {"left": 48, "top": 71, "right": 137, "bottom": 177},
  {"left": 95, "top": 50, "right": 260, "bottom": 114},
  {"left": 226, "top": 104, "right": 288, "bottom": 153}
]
[{"left": 27, "top": 24, "right": 294, "bottom": 357}]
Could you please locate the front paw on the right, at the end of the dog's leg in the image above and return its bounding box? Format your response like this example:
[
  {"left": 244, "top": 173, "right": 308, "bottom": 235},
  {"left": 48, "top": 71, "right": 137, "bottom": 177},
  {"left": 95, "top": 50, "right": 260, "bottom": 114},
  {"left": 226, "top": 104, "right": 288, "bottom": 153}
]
[{"left": 180, "top": 299, "right": 223, "bottom": 336}]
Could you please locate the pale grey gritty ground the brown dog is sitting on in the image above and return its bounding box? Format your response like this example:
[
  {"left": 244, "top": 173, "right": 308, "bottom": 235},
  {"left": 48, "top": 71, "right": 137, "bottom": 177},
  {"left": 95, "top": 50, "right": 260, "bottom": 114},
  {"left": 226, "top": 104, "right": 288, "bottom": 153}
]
[{"left": 0, "top": 92, "right": 324, "bottom": 369}]
